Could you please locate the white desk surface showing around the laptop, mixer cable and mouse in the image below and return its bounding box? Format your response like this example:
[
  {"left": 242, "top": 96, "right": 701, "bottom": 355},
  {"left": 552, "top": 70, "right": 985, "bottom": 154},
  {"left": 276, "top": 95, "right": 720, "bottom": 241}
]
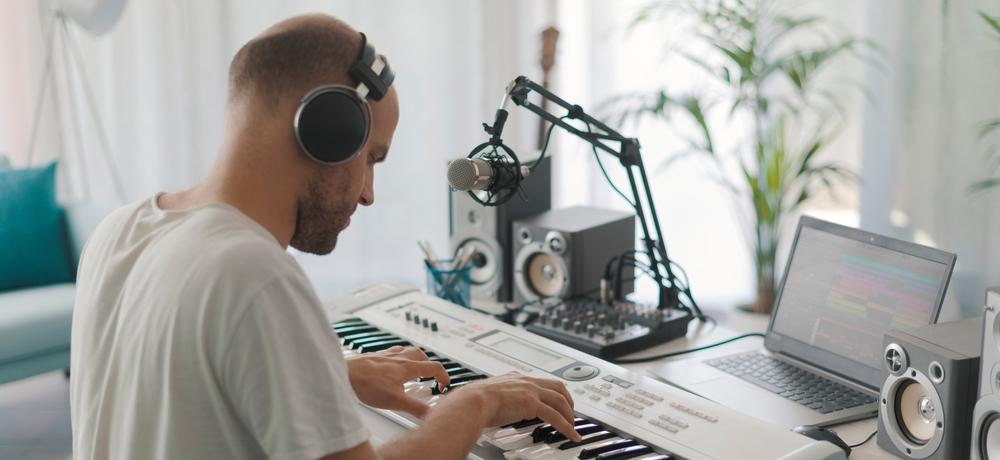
[{"left": 624, "top": 308, "right": 898, "bottom": 460}]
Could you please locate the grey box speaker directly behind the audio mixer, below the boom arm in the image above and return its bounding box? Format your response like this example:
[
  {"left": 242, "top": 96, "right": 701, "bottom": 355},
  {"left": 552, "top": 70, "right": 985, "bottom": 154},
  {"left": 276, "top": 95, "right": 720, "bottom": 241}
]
[{"left": 513, "top": 206, "right": 635, "bottom": 304}]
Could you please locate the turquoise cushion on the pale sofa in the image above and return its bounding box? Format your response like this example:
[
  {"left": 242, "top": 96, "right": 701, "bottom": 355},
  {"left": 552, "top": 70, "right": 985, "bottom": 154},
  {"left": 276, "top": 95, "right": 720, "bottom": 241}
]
[{"left": 0, "top": 163, "right": 73, "bottom": 291}]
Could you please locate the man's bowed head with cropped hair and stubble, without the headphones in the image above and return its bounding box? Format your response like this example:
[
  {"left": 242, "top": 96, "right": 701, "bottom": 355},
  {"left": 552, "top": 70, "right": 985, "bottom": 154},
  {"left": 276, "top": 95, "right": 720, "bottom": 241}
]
[{"left": 229, "top": 15, "right": 399, "bottom": 254}]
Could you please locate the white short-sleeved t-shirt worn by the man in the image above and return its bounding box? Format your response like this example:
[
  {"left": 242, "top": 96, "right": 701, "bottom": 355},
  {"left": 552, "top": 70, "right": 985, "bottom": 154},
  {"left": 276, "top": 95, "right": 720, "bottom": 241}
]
[{"left": 70, "top": 197, "right": 369, "bottom": 460}]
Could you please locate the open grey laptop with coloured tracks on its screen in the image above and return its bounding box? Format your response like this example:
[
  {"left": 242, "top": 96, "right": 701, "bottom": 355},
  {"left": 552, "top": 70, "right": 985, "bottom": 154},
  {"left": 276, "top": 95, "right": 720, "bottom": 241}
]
[{"left": 652, "top": 217, "right": 956, "bottom": 428}]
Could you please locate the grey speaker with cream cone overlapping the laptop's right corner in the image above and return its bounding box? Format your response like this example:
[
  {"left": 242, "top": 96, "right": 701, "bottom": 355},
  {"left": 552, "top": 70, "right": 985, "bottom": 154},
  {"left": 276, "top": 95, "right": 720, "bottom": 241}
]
[{"left": 878, "top": 318, "right": 982, "bottom": 460}]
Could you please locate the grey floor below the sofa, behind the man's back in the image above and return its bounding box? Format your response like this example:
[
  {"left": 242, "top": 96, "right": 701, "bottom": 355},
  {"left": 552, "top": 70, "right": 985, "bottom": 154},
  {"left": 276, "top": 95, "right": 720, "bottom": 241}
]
[{"left": 0, "top": 371, "right": 73, "bottom": 460}]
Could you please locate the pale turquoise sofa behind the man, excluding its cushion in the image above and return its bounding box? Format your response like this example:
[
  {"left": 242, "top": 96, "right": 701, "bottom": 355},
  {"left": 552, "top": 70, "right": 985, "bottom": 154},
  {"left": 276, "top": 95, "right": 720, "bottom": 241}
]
[{"left": 0, "top": 204, "right": 111, "bottom": 384}]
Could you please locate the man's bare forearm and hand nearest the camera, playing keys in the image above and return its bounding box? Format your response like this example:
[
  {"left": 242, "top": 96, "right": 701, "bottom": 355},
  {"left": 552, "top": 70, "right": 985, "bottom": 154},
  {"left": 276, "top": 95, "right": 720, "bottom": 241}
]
[{"left": 322, "top": 374, "right": 580, "bottom": 460}]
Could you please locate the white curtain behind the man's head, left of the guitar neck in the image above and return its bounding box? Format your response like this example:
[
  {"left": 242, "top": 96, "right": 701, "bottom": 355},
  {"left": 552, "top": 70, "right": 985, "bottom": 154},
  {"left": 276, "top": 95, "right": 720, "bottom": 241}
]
[{"left": 0, "top": 0, "right": 564, "bottom": 295}]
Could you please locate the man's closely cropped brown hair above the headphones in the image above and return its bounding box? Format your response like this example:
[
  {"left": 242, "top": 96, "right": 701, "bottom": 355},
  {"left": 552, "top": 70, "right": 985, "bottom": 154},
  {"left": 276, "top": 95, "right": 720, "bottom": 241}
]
[{"left": 229, "top": 15, "right": 361, "bottom": 111}]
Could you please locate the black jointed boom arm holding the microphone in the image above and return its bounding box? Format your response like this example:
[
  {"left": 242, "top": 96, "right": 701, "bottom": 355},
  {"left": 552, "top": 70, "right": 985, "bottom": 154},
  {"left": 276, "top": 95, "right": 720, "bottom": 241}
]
[{"left": 498, "top": 76, "right": 703, "bottom": 318}]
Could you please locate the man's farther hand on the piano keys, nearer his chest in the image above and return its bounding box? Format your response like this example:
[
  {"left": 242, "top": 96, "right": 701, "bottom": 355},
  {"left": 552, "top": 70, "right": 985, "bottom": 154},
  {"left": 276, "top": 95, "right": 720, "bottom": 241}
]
[{"left": 347, "top": 346, "right": 451, "bottom": 418}]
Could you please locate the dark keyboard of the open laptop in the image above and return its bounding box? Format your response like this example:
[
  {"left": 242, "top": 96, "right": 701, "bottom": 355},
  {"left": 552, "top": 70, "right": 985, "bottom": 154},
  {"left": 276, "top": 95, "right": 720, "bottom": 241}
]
[{"left": 705, "top": 353, "right": 875, "bottom": 414}]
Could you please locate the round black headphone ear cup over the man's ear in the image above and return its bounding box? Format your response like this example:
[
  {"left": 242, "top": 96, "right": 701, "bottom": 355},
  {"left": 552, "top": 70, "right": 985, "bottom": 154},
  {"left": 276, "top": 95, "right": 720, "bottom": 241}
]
[{"left": 295, "top": 88, "right": 371, "bottom": 164}]
